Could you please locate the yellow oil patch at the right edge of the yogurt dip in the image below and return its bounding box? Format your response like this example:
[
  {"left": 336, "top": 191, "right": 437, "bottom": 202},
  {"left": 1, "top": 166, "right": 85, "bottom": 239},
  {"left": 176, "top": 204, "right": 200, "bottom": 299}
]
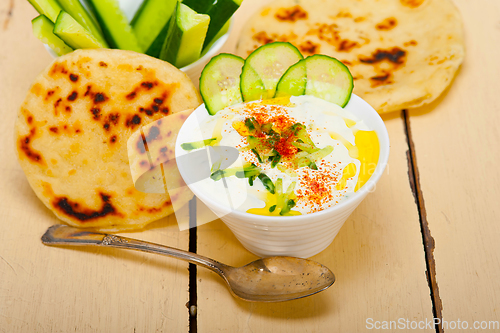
[{"left": 354, "top": 131, "right": 380, "bottom": 191}]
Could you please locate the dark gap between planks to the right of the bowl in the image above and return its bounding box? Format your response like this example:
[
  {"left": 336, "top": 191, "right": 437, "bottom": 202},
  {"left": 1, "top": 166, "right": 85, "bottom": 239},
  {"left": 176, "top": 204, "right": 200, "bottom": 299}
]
[{"left": 401, "top": 110, "right": 444, "bottom": 333}]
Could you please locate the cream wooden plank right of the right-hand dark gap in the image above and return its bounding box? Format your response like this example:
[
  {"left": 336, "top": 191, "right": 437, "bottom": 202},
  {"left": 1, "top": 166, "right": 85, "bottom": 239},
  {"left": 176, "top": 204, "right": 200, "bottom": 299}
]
[{"left": 410, "top": 0, "right": 500, "bottom": 331}]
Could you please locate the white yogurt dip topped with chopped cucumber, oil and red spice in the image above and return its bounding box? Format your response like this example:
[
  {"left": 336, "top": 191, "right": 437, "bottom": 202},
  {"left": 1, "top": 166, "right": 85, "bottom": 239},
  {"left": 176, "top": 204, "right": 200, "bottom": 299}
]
[{"left": 181, "top": 95, "right": 380, "bottom": 216}]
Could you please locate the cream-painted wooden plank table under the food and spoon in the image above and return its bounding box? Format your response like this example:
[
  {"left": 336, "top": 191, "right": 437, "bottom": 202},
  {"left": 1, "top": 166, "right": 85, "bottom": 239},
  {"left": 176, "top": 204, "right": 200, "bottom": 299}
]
[{"left": 0, "top": 0, "right": 500, "bottom": 333}]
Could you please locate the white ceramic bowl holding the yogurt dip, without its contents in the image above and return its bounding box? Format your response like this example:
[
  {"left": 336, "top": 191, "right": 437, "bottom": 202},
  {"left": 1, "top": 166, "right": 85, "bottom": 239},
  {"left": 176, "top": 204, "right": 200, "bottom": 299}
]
[{"left": 176, "top": 94, "right": 389, "bottom": 258}]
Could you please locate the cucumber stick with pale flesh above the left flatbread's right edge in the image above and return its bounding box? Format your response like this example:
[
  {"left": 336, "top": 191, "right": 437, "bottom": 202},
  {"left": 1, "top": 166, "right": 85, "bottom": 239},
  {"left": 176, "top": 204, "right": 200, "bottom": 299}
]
[{"left": 160, "top": 3, "right": 210, "bottom": 68}]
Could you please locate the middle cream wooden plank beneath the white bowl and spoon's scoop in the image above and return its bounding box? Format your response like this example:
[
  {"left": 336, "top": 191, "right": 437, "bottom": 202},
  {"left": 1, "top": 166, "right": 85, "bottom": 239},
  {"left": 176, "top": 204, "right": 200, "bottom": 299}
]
[{"left": 197, "top": 1, "right": 434, "bottom": 326}]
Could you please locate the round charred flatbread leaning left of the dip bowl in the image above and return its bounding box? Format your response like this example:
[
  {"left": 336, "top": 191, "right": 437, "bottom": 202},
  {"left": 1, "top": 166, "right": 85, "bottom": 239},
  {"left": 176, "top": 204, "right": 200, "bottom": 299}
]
[{"left": 15, "top": 50, "right": 201, "bottom": 230}]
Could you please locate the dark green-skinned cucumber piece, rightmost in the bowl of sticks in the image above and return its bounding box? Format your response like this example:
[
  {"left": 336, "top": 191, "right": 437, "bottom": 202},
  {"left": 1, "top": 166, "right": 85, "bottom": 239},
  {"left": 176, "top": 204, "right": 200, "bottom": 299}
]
[{"left": 183, "top": 0, "right": 243, "bottom": 50}]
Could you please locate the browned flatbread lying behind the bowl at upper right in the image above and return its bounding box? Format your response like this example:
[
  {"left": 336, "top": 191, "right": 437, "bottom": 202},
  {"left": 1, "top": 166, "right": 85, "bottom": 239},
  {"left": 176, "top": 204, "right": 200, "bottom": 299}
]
[{"left": 236, "top": 0, "right": 465, "bottom": 113}]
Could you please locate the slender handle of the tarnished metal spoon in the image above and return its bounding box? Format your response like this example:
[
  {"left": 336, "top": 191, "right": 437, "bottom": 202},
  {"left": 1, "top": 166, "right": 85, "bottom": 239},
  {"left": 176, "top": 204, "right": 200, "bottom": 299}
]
[{"left": 42, "top": 224, "right": 225, "bottom": 276}]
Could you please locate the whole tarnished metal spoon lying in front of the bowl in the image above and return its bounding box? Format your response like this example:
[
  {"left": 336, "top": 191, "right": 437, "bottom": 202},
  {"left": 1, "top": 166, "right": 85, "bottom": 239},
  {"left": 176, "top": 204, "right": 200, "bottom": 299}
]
[{"left": 42, "top": 225, "right": 335, "bottom": 302}]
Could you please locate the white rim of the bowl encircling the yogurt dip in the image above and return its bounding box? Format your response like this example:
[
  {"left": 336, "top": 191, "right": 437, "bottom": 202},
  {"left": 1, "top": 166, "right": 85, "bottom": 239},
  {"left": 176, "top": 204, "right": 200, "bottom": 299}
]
[{"left": 175, "top": 93, "right": 390, "bottom": 225}]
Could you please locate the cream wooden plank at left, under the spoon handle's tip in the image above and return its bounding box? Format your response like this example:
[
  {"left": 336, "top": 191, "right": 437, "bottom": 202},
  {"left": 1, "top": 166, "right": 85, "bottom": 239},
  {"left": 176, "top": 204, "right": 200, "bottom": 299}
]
[{"left": 0, "top": 0, "right": 189, "bottom": 333}]
